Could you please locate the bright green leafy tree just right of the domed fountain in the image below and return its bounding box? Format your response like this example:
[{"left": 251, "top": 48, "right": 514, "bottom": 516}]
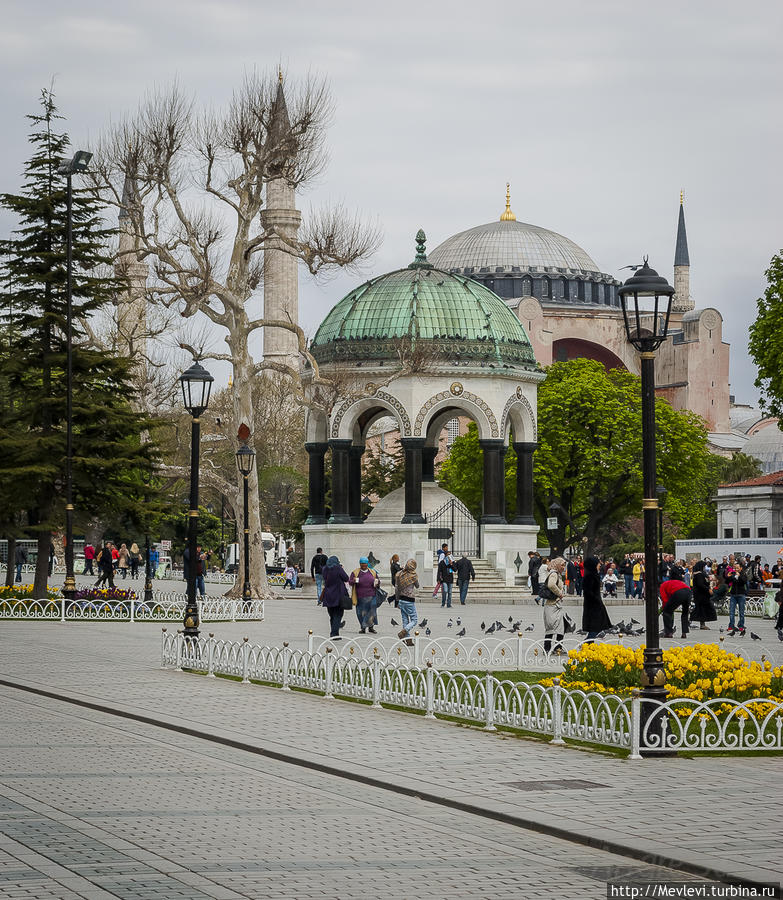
[{"left": 440, "top": 359, "right": 710, "bottom": 550}]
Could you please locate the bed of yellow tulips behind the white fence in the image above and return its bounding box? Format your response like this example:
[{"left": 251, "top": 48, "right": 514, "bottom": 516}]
[{"left": 539, "top": 643, "right": 783, "bottom": 718}]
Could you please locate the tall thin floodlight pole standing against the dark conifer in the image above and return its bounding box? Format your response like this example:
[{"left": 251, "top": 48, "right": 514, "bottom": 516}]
[{"left": 57, "top": 150, "right": 92, "bottom": 600}]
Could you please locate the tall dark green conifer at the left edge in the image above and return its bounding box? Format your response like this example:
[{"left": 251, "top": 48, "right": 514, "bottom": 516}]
[{"left": 0, "top": 91, "right": 159, "bottom": 596}]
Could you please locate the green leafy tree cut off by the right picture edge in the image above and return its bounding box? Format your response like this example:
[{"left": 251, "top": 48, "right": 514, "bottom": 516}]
[{"left": 748, "top": 250, "right": 783, "bottom": 419}]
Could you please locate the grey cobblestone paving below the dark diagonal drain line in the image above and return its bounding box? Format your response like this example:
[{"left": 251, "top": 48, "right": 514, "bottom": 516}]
[{"left": 0, "top": 688, "right": 696, "bottom": 900}]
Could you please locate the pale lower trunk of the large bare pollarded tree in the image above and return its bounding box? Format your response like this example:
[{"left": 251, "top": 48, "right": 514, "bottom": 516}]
[{"left": 228, "top": 348, "right": 272, "bottom": 599}]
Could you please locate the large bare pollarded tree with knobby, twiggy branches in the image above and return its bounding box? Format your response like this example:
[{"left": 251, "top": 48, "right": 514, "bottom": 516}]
[{"left": 92, "top": 74, "right": 378, "bottom": 592}]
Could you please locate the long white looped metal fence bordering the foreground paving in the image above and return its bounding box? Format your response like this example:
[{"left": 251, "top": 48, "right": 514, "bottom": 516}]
[{"left": 161, "top": 628, "right": 783, "bottom": 759}]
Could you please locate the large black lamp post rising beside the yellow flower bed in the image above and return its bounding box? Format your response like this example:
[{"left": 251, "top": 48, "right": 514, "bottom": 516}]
[{"left": 618, "top": 257, "right": 674, "bottom": 756}]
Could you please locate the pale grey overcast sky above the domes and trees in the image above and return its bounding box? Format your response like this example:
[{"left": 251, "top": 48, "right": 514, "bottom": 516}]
[{"left": 0, "top": 0, "right": 783, "bottom": 401}]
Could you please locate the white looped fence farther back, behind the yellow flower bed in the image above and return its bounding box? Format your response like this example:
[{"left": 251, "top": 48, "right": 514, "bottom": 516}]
[{"left": 307, "top": 631, "right": 777, "bottom": 671}]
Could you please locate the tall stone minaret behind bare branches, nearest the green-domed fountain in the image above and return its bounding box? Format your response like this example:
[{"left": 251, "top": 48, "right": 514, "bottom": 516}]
[{"left": 261, "top": 72, "right": 302, "bottom": 371}]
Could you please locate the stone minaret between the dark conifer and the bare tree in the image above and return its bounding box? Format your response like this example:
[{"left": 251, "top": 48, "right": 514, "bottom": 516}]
[{"left": 114, "top": 178, "right": 149, "bottom": 360}]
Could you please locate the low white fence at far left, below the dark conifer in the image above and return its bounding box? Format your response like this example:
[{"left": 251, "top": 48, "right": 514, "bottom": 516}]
[{"left": 0, "top": 591, "right": 264, "bottom": 623}]
